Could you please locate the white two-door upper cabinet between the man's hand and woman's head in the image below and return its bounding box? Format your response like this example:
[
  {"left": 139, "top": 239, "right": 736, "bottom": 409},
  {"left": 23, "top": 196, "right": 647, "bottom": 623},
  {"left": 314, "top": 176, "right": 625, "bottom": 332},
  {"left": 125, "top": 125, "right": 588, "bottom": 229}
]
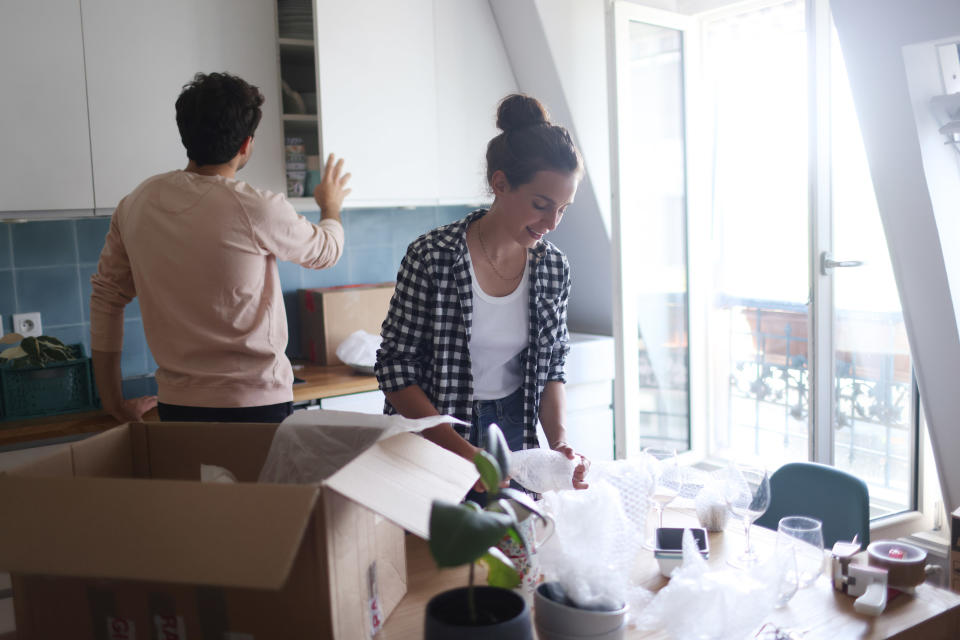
[{"left": 315, "top": 0, "right": 516, "bottom": 207}]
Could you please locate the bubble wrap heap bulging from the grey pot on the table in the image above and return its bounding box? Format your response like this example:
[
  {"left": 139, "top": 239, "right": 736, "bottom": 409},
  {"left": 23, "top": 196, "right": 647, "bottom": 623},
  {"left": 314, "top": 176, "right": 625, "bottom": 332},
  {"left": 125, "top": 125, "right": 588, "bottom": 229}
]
[{"left": 540, "top": 454, "right": 652, "bottom": 611}]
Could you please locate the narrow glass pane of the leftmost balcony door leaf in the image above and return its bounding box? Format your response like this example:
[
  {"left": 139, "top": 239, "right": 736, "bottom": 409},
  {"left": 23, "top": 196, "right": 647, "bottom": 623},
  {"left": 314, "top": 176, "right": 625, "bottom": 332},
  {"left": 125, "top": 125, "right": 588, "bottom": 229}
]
[{"left": 613, "top": 3, "right": 691, "bottom": 456}]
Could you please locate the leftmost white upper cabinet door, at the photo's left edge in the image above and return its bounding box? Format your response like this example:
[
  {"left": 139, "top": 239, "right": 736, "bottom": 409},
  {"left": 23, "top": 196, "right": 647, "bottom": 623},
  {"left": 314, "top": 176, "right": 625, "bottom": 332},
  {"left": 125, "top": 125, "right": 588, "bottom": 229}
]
[{"left": 0, "top": 0, "right": 93, "bottom": 213}]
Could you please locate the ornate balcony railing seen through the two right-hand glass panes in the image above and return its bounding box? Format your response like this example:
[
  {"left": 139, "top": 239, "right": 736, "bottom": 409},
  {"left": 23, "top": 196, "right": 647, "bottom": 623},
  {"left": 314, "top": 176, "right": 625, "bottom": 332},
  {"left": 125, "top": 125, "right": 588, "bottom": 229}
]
[{"left": 727, "top": 301, "right": 913, "bottom": 512}]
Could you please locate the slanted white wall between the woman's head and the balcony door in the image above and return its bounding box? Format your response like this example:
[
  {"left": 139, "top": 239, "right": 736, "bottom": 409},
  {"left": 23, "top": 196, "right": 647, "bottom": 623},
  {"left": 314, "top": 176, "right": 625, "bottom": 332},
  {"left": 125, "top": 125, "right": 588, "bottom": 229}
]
[{"left": 490, "top": 0, "right": 613, "bottom": 335}]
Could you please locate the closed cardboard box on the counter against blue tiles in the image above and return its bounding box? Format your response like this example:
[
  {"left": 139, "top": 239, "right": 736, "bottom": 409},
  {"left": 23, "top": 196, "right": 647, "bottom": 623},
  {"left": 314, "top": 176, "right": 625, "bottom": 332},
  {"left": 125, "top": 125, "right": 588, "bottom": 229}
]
[{"left": 299, "top": 282, "right": 394, "bottom": 365}]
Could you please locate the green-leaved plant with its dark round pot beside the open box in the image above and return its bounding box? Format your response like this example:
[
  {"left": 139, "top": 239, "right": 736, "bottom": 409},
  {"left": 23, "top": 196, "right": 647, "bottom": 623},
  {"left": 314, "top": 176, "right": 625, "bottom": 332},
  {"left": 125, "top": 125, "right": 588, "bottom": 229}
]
[{"left": 424, "top": 424, "right": 543, "bottom": 640}]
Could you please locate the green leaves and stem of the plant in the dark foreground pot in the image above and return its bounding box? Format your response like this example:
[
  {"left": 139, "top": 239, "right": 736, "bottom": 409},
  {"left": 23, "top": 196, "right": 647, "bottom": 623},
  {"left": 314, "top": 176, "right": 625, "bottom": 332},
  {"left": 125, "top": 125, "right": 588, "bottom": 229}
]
[{"left": 430, "top": 424, "right": 543, "bottom": 624}]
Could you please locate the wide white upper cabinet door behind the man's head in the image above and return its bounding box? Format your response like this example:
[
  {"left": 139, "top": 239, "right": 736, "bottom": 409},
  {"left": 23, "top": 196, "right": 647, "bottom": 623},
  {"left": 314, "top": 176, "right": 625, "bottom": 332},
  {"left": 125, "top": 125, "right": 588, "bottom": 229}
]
[{"left": 81, "top": 0, "right": 284, "bottom": 210}]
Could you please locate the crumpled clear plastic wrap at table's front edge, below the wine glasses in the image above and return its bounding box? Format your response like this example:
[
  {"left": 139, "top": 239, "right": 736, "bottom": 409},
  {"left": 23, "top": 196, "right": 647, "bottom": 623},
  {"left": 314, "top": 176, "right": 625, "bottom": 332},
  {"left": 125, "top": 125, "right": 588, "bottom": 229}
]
[{"left": 633, "top": 531, "right": 783, "bottom": 640}]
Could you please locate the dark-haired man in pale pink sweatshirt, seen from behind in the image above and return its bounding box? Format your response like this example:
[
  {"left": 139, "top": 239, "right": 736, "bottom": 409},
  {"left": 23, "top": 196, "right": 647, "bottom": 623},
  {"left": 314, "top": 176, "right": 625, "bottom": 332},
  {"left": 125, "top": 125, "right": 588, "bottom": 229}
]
[{"left": 90, "top": 73, "right": 350, "bottom": 422}]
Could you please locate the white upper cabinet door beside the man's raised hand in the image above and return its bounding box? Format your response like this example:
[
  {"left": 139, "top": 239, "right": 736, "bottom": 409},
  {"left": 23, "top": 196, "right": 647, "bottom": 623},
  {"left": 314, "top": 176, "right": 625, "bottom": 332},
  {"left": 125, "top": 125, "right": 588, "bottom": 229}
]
[{"left": 315, "top": 0, "right": 440, "bottom": 206}]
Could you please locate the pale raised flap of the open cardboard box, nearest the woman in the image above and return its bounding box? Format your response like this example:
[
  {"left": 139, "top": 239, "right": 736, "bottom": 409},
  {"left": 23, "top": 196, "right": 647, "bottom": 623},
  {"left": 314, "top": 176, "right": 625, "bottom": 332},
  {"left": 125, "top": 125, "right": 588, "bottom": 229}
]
[{"left": 324, "top": 433, "right": 478, "bottom": 539}]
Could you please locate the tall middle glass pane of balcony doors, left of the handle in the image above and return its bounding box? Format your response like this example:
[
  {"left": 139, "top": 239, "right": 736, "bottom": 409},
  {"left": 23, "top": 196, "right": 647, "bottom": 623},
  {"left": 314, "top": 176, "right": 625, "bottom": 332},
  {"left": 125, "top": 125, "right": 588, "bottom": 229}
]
[{"left": 701, "top": 0, "right": 811, "bottom": 468}]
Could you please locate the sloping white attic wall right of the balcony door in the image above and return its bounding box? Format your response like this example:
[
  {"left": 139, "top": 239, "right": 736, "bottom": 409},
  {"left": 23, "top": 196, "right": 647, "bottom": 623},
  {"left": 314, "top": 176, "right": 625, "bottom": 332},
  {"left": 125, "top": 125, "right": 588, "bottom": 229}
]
[{"left": 832, "top": 0, "right": 960, "bottom": 510}]
